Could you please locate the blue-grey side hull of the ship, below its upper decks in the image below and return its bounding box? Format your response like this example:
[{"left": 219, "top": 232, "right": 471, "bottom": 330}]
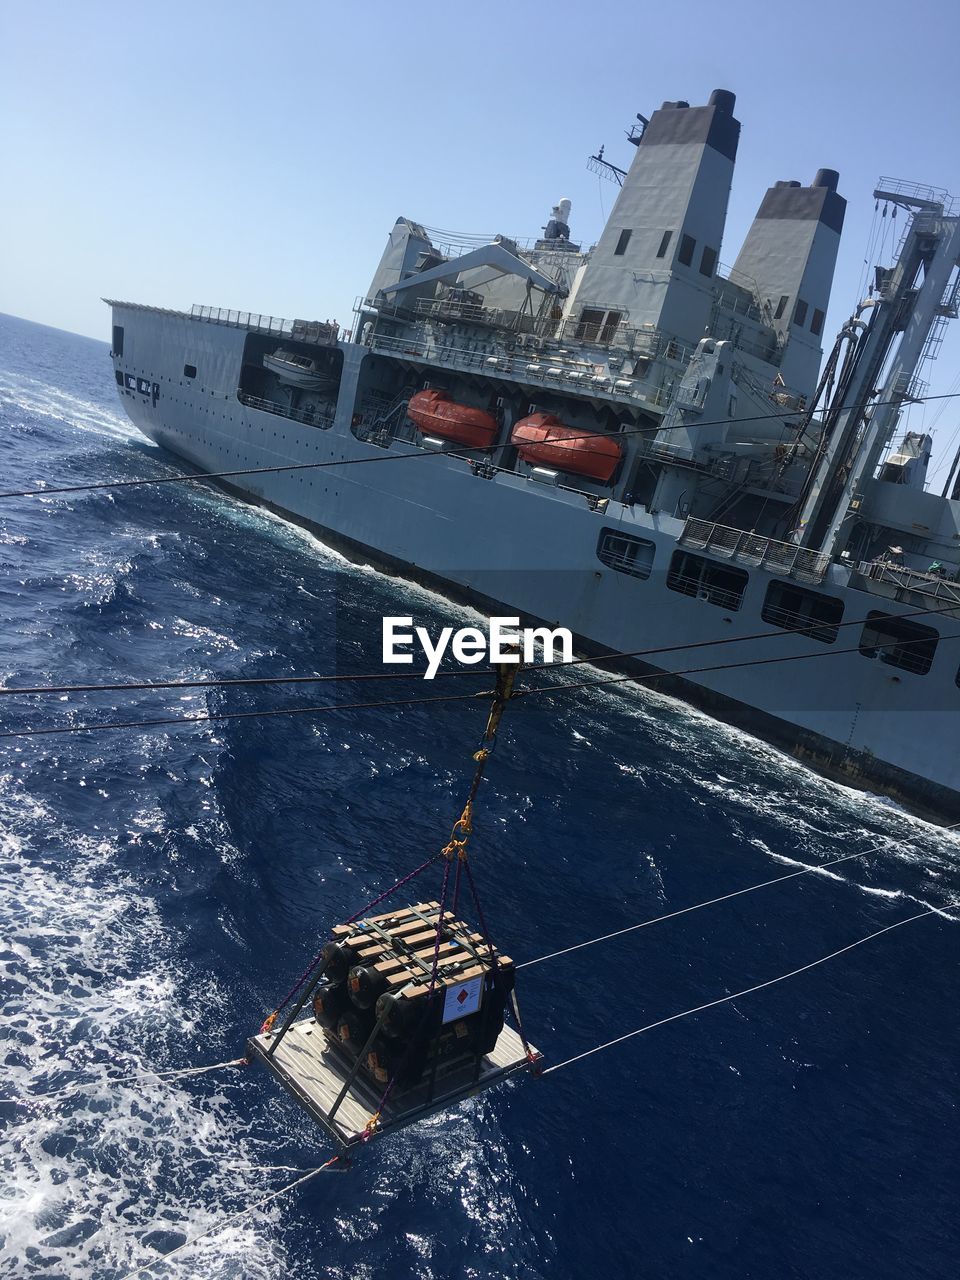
[{"left": 108, "top": 311, "right": 960, "bottom": 820}]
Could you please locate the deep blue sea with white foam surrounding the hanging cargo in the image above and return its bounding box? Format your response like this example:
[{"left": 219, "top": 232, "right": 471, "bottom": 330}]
[{"left": 0, "top": 314, "right": 960, "bottom": 1280}]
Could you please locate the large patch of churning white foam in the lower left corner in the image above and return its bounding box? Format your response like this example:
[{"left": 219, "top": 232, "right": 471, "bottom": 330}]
[{"left": 0, "top": 776, "right": 296, "bottom": 1280}]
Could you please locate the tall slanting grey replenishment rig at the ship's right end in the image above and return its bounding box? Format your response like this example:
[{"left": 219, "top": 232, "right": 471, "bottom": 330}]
[{"left": 796, "top": 183, "right": 960, "bottom": 556}]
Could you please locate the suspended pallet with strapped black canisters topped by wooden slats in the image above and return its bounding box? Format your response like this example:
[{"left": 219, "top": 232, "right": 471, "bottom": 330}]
[{"left": 247, "top": 902, "right": 539, "bottom": 1148}]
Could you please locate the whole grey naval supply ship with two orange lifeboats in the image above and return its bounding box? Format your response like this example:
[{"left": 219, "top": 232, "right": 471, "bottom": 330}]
[{"left": 105, "top": 90, "right": 960, "bottom": 819}]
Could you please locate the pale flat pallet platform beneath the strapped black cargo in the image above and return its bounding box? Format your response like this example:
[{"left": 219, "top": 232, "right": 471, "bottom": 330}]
[{"left": 247, "top": 1018, "right": 536, "bottom": 1147}]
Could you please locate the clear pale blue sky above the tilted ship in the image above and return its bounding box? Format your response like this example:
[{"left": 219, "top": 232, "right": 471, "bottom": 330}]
[{"left": 0, "top": 0, "right": 960, "bottom": 476}]
